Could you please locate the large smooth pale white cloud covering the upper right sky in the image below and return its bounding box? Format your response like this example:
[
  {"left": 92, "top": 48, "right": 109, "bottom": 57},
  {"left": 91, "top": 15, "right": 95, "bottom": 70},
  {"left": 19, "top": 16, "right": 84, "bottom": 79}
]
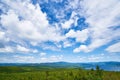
[{"left": 75, "top": 0, "right": 120, "bottom": 52}]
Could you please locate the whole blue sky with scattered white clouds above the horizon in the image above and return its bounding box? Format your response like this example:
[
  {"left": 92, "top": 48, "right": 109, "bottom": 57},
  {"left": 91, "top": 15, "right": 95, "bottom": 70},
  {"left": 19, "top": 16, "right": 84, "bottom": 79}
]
[{"left": 0, "top": 0, "right": 120, "bottom": 63}]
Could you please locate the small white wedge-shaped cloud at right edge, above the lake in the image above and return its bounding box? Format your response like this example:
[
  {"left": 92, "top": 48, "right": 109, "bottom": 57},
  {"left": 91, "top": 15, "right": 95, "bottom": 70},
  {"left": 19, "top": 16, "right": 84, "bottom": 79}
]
[{"left": 106, "top": 42, "right": 120, "bottom": 53}]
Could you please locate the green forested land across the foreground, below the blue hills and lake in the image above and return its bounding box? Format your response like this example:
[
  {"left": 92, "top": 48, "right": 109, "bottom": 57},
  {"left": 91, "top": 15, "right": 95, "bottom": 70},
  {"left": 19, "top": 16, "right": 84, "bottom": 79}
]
[{"left": 0, "top": 66, "right": 120, "bottom": 80}]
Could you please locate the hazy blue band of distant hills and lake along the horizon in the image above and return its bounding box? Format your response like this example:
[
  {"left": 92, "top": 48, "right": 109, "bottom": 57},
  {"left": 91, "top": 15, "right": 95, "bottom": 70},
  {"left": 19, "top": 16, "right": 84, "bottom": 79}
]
[{"left": 0, "top": 61, "right": 120, "bottom": 71}]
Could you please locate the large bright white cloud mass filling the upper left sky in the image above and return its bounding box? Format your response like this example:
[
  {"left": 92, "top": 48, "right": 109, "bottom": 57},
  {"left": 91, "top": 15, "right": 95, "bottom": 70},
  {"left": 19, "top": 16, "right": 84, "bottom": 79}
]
[{"left": 0, "top": 0, "right": 65, "bottom": 52}]
